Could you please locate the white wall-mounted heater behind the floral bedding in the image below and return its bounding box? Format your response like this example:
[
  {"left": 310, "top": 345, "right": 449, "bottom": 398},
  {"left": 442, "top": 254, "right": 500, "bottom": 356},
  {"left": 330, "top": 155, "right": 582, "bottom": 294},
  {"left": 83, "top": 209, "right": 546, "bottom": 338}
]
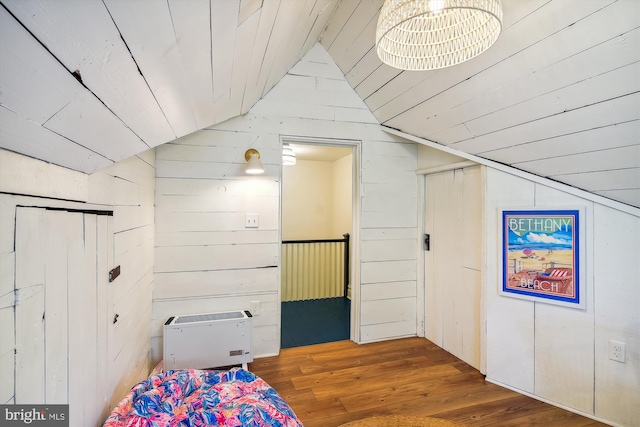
[{"left": 163, "top": 311, "right": 253, "bottom": 371}]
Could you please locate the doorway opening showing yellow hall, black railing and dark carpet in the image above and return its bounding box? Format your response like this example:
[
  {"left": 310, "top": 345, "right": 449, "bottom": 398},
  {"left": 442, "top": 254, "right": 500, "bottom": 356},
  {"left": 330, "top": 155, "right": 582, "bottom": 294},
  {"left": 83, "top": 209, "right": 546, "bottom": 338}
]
[{"left": 280, "top": 137, "right": 357, "bottom": 348}]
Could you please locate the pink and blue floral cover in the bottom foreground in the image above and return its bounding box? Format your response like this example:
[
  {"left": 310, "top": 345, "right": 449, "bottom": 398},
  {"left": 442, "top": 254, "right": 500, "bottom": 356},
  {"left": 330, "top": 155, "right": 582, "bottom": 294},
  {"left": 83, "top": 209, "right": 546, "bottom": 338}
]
[{"left": 103, "top": 368, "right": 302, "bottom": 427}]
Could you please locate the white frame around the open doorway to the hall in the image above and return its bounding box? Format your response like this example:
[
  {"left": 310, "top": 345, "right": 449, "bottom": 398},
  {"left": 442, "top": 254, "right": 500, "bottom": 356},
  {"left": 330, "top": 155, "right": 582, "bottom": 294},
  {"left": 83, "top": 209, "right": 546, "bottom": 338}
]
[{"left": 278, "top": 135, "right": 362, "bottom": 348}]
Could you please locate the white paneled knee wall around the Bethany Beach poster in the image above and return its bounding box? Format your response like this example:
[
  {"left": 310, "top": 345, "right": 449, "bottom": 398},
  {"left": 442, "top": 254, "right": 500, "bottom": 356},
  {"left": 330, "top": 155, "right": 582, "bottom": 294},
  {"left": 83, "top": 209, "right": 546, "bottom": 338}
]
[{"left": 485, "top": 168, "right": 640, "bottom": 426}]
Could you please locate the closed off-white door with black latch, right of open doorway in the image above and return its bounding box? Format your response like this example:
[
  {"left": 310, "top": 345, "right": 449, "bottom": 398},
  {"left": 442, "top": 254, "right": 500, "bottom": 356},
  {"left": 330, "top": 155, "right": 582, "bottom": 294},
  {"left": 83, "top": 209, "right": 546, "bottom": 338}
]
[{"left": 424, "top": 166, "right": 483, "bottom": 369}]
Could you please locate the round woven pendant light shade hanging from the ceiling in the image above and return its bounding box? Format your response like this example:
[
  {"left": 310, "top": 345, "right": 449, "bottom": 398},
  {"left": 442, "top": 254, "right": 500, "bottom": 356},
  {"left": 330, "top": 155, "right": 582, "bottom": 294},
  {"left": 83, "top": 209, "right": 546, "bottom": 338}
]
[{"left": 376, "top": 0, "right": 502, "bottom": 71}]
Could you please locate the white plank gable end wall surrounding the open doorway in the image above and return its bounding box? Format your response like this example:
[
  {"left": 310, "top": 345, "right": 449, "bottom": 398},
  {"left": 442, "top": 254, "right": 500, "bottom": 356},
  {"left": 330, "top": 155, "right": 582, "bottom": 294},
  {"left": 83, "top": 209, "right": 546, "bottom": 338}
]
[{"left": 152, "top": 41, "right": 417, "bottom": 359}]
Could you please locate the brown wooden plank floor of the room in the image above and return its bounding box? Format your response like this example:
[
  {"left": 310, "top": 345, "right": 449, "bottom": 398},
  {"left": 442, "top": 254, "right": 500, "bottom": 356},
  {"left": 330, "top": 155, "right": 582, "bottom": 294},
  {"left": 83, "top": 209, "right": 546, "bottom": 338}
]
[{"left": 249, "top": 338, "right": 606, "bottom": 427}]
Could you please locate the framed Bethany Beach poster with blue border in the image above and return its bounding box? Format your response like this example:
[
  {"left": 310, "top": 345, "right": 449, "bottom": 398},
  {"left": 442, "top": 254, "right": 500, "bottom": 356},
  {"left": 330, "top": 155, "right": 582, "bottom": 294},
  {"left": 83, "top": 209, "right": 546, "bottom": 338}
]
[{"left": 500, "top": 208, "right": 585, "bottom": 309}]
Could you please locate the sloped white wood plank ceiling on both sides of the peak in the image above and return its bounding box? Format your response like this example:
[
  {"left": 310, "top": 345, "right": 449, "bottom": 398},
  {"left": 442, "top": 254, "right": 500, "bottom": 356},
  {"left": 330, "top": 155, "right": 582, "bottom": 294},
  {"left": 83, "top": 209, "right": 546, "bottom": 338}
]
[{"left": 0, "top": 0, "right": 640, "bottom": 207}]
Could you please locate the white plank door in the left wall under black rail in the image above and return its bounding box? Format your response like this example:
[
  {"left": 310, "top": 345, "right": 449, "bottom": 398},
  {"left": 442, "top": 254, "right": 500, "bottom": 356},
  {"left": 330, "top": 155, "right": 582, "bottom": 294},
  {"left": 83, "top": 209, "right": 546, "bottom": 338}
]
[{"left": 15, "top": 207, "right": 111, "bottom": 426}]
